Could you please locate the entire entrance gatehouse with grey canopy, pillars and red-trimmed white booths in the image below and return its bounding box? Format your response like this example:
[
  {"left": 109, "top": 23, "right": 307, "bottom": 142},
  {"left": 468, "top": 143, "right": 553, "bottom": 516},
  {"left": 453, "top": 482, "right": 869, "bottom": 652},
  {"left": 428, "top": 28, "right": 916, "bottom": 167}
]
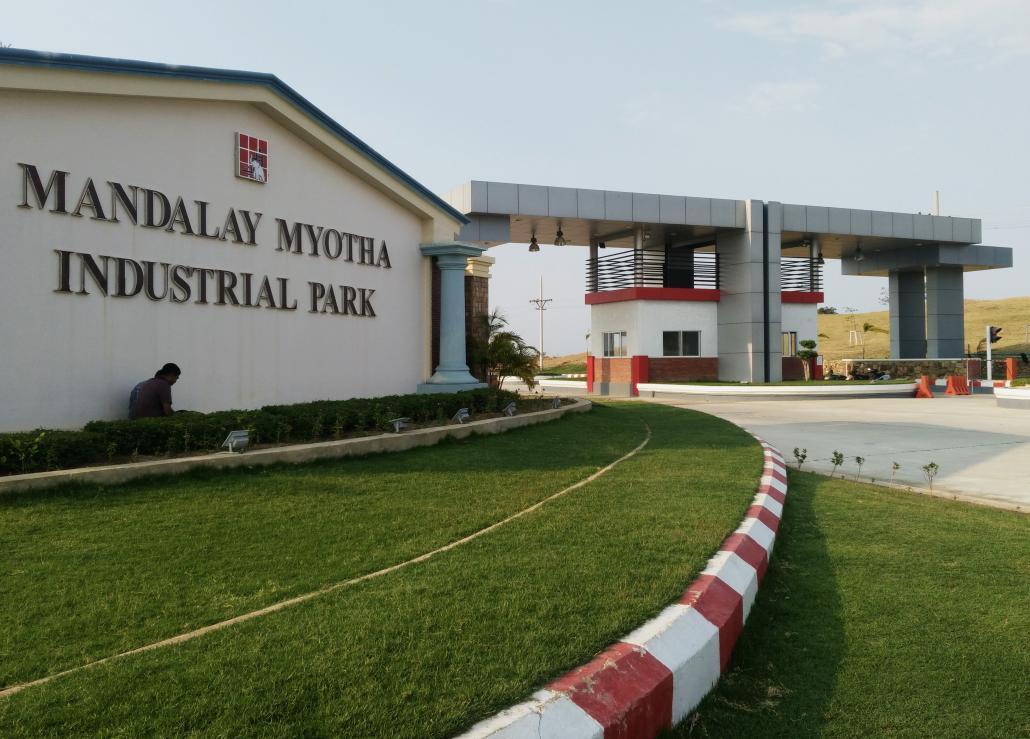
[{"left": 447, "top": 180, "right": 1012, "bottom": 394}]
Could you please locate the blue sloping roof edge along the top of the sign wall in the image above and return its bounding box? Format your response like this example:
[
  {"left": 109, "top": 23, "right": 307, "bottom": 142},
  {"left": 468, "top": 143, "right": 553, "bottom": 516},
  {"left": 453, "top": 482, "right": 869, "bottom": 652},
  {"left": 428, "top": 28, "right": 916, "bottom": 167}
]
[{"left": 0, "top": 48, "right": 469, "bottom": 224}]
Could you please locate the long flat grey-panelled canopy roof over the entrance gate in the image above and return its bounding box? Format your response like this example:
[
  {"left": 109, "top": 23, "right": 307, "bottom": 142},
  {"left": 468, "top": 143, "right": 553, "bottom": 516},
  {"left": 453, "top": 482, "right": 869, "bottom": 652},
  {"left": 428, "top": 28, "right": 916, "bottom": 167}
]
[{"left": 444, "top": 180, "right": 1012, "bottom": 274}]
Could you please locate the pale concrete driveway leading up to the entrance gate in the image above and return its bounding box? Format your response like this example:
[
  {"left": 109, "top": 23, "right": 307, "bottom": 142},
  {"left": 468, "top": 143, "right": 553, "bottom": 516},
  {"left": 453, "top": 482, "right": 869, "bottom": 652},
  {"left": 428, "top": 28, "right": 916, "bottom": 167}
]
[{"left": 653, "top": 395, "right": 1030, "bottom": 511}]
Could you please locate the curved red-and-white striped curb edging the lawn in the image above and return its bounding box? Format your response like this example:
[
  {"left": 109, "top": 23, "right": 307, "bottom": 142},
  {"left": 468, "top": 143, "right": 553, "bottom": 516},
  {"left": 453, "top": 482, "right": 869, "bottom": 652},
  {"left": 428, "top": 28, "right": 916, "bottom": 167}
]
[{"left": 459, "top": 439, "right": 787, "bottom": 739}]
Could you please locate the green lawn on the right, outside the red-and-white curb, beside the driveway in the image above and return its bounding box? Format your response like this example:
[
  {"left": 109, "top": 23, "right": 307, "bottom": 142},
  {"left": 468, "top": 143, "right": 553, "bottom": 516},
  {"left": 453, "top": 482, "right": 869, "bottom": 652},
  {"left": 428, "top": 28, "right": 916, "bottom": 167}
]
[{"left": 675, "top": 471, "right": 1030, "bottom": 738}]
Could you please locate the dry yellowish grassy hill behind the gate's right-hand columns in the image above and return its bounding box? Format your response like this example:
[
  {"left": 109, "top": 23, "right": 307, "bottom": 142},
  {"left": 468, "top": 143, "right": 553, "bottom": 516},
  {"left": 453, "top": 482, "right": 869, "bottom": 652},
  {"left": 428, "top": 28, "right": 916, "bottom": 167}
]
[{"left": 811, "top": 297, "right": 1030, "bottom": 360}]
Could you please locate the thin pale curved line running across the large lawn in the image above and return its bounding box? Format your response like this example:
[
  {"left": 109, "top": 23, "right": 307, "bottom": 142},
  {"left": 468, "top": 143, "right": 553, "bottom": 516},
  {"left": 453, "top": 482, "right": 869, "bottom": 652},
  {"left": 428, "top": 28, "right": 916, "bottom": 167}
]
[{"left": 0, "top": 424, "right": 651, "bottom": 698}]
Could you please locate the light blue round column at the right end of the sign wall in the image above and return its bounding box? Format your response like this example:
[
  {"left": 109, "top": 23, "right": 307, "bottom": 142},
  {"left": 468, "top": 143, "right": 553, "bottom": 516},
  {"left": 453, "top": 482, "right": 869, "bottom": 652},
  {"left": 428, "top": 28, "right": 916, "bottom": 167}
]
[{"left": 418, "top": 241, "right": 486, "bottom": 393}]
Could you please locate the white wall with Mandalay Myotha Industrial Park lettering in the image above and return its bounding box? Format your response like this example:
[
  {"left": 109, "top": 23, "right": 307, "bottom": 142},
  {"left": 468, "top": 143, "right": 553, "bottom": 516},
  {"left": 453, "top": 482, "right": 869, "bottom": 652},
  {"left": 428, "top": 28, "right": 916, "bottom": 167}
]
[{"left": 0, "top": 93, "right": 425, "bottom": 431}]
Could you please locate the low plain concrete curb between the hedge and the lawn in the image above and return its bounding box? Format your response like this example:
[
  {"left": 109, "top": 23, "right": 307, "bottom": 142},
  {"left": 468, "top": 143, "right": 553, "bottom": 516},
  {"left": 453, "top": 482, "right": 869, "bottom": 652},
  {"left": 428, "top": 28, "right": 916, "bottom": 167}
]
[{"left": 0, "top": 399, "right": 592, "bottom": 495}]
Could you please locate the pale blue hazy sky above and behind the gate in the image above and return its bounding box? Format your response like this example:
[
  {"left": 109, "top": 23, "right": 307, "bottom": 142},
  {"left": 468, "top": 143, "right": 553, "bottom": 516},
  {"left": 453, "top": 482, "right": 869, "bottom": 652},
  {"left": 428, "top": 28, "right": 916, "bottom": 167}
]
[{"left": 0, "top": 0, "right": 1030, "bottom": 355}]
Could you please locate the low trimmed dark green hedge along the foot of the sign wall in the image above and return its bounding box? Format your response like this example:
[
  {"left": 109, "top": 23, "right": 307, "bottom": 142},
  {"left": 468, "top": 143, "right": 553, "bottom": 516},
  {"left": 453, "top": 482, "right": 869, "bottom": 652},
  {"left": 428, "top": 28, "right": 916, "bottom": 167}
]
[{"left": 0, "top": 388, "right": 517, "bottom": 475}]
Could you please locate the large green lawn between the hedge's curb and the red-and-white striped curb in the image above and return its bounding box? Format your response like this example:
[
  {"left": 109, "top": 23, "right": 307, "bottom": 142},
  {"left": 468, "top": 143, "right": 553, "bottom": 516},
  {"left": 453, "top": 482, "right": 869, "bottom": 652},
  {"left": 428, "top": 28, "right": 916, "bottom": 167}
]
[{"left": 0, "top": 404, "right": 761, "bottom": 737}]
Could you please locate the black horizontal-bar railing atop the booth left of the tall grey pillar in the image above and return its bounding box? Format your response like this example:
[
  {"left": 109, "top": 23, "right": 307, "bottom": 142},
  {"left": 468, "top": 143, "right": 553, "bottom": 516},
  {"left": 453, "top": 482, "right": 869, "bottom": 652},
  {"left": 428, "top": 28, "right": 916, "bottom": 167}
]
[{"left": 586, "top": 248, "right": 719, "bottom": 293}]
